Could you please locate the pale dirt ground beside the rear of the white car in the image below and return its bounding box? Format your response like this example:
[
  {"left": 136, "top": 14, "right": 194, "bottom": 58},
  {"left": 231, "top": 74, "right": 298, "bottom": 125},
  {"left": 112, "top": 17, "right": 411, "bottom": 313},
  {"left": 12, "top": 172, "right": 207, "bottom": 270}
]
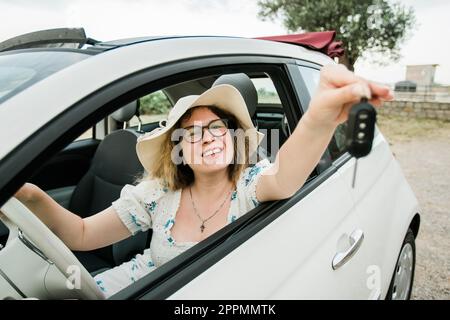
[{"left": 378, "top": 116, "right": 450, "bottom": 300}]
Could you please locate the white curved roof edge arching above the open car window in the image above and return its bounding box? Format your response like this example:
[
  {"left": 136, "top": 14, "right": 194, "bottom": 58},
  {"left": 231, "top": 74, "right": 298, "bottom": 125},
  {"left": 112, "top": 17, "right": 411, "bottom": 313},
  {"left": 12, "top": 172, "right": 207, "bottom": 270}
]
[{"left": 0, "top": 36, "right": 333, "bottom": 159}]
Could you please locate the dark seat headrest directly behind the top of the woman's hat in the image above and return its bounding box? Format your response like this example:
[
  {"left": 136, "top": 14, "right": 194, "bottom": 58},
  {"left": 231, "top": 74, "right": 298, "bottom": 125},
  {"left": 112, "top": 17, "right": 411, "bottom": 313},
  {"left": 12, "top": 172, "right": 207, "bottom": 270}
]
[{"left": 212, "top": 73, "right": 258, "bottom": 118}]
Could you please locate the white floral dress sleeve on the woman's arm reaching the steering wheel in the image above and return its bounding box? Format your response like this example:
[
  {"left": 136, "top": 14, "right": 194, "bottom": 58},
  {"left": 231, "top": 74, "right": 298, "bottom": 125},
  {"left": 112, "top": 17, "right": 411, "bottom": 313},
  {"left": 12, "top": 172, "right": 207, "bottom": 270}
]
[{"left": 112, "top": 180, "right": 167, "bottom": 235}]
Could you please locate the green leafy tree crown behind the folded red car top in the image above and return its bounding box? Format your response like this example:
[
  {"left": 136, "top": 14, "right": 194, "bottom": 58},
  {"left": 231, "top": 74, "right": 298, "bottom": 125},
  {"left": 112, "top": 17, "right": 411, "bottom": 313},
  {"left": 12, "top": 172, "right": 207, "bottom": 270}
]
[{"left": 258, "top": 0, "right": 415, "bottom": 69}]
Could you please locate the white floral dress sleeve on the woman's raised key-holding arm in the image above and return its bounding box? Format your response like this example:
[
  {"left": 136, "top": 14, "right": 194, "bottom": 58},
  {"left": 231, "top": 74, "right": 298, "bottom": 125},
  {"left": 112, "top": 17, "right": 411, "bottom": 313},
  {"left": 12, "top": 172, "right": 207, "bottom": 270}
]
[{"left": 237, "top": 159, "right": 273, "bottom": 210}]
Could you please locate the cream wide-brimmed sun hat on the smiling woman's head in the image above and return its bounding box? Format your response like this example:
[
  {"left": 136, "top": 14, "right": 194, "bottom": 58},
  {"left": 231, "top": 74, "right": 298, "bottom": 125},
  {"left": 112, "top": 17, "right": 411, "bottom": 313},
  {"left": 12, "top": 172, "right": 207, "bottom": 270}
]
[{"left": 136, "top": 84, "right": 264, "bottom": 172}]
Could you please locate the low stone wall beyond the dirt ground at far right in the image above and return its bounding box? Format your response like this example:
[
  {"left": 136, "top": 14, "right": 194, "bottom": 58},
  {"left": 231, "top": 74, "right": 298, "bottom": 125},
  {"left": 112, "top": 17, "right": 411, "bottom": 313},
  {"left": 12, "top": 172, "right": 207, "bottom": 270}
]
[{"left": 378, "top": 100, "right": 450, "bottom": 121}]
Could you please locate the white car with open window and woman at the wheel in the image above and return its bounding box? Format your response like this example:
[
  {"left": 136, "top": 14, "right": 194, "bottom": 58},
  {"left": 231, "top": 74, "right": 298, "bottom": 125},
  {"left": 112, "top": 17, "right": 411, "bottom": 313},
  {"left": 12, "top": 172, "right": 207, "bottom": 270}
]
[{"left": 0, "top": 30, "right": 420, "bottom": 299}]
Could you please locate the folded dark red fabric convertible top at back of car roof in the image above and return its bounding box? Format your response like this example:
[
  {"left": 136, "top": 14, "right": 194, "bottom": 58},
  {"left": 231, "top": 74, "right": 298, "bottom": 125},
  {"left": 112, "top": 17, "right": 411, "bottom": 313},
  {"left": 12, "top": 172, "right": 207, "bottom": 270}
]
[{"left": 255, "top": 31, "right": 344, "bottom": 58}]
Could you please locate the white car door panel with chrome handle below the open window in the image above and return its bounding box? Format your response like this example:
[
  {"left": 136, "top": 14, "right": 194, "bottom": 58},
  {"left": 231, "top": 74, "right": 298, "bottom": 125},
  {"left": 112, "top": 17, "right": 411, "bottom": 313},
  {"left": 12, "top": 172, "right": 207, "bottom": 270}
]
[{"left": 165, "top": 65, "right": 371, "bottom": 299}]
